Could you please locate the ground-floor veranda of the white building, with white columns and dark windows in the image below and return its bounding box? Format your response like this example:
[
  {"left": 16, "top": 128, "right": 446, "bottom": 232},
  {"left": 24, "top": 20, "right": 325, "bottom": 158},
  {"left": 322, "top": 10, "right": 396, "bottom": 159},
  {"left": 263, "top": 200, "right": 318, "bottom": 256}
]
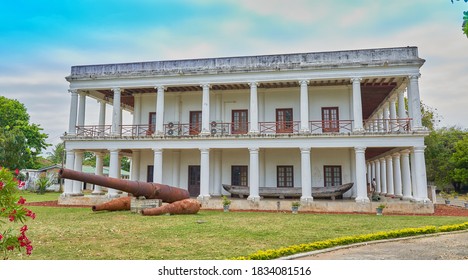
[{"left": 62, "top": 144, "right": 430, "bottom": 208}]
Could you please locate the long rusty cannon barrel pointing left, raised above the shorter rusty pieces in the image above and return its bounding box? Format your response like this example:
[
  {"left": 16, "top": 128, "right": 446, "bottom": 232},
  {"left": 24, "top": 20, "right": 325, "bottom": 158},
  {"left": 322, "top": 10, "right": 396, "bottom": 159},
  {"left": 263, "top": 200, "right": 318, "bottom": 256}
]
[{"left": 59, "top": 168, "right": 190, "bottom": 203}]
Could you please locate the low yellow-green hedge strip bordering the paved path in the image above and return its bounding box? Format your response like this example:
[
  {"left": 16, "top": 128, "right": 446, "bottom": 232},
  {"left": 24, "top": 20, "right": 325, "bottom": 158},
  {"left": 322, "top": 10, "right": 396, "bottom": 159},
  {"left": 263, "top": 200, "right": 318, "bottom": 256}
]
[{"left": 234, "top": 222, "right": 468, "bottom": 260}]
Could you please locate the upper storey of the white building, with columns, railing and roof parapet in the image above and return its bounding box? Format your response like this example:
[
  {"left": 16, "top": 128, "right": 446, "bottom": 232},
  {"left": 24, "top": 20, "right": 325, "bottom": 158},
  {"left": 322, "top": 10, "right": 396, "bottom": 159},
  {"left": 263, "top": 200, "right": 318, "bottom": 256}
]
[{"left": 66, "top": 47, "right": 424, "bottom": 142}]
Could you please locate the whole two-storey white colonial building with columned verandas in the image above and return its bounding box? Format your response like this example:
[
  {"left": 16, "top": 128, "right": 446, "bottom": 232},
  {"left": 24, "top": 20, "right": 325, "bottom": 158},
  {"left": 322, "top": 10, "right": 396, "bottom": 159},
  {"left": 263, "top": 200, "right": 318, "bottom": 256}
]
[{"left": 64, "top": 47, "right": 429, "bottom": 206}]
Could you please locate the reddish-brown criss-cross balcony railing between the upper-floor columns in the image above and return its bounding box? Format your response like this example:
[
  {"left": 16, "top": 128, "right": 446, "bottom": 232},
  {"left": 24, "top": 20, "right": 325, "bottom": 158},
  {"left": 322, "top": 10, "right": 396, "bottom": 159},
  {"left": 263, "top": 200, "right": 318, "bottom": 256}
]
[{"left": 71, "top": 118, "right": 411, "bottom": 138}]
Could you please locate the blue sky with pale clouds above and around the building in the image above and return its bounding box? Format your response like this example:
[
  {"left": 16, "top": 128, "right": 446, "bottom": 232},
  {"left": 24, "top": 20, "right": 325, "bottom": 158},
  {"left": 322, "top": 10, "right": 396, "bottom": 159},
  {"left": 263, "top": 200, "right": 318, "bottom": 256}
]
[{"left": 0, "top": 0, "right": 468, "bottom": 154}]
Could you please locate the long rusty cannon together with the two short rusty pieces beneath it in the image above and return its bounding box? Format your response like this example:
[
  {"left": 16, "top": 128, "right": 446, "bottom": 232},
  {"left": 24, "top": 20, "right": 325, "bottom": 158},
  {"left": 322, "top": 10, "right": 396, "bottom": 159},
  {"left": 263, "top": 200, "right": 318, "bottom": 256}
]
[{"left": 59, "top": 168, "right": 201, "bottom": 215}]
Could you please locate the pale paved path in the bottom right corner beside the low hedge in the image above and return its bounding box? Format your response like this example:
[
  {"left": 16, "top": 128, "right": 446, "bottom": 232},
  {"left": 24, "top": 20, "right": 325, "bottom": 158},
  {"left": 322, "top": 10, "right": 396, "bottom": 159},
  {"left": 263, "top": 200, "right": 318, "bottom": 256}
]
[{"left": 288, "top": 231, "right": 468, "bottom": 260}]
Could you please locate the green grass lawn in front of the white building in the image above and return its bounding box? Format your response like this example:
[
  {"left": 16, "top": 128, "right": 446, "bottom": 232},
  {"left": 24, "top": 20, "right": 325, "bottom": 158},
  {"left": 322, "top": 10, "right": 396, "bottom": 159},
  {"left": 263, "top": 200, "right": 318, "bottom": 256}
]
[{"left": 8, "top": 193, "right": 468, "bottom": 260}]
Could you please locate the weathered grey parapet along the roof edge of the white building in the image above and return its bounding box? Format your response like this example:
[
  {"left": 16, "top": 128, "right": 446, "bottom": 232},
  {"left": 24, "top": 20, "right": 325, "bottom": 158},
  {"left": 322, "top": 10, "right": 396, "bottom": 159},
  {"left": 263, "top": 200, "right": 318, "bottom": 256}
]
[{"left": 66, "top": 47, "right": 425, "bottom": 81}]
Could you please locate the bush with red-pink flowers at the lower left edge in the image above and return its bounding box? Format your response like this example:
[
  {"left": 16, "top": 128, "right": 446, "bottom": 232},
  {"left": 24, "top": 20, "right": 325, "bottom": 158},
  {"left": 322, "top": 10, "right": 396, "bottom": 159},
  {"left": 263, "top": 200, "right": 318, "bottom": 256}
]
[{"left": 0, "top": 167, "right": 36, "bottom": 259}]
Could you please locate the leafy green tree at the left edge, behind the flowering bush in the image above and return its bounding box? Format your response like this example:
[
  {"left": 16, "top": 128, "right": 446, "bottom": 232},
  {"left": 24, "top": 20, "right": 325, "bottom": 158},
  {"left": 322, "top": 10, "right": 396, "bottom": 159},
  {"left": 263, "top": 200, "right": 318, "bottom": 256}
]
[{"left": 0, "top": 96, "right": 49, "bottom": 169}]
